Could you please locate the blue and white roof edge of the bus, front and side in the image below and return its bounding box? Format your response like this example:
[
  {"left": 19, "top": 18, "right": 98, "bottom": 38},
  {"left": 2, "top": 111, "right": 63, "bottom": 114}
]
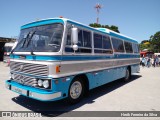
[{"left": 21, "top": 18, "right": 138, "bottom": 44}]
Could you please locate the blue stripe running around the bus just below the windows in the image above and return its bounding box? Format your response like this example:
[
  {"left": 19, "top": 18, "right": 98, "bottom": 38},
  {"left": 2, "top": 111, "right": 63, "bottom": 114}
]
[{"left": 10, "top": 54, "right": 139, "bottom": 61}]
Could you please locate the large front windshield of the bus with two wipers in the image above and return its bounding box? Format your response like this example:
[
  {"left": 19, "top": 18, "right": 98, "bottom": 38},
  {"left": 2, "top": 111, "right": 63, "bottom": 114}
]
[{"left": 13, "top": 23, "right": 64, "bottom": 52}]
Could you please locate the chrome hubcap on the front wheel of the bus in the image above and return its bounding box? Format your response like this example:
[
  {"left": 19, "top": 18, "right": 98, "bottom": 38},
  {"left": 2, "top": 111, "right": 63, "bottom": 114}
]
[{"left": 70, "top": 81, "right": 82, "bottom": 99}]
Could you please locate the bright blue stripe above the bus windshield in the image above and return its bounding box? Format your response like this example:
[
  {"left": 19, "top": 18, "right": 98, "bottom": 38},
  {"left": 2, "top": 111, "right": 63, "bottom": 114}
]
[{"left": 21, "top": 19, "right": 64, "bottom": 29}]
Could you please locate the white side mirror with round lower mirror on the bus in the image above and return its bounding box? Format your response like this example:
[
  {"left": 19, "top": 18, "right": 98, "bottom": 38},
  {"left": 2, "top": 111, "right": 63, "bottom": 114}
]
[{"left": 71, "top": 28, "right": 78, "bottom": 51}]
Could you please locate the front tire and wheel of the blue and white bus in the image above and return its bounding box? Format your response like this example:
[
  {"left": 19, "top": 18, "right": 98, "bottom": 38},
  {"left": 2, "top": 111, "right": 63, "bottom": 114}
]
[{"left": 68, "top": 77, "right": 85, "bottom": 104}]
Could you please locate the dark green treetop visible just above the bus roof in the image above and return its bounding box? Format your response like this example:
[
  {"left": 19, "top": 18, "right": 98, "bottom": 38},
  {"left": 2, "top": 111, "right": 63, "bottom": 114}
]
[{"left": 89, "top": 23, "right": 120, "bottom": 33}]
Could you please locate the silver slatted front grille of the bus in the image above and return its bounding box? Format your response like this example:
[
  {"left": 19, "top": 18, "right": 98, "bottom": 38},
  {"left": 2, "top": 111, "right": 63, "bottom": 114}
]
[{"left": 10, "top": 61, "right": 48, "bottom": 76}]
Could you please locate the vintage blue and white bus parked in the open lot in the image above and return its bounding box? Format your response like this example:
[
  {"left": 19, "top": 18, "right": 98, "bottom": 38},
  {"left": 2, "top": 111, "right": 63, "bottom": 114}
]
[{"left": 6, "top": 18, "right": 140, "bottom": 103}]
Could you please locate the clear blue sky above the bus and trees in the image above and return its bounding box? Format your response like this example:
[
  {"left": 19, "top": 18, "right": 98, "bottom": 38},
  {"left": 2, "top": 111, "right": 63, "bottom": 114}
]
[{"left": 0, "top": 0, "right": 160, "bottom": 43}]
